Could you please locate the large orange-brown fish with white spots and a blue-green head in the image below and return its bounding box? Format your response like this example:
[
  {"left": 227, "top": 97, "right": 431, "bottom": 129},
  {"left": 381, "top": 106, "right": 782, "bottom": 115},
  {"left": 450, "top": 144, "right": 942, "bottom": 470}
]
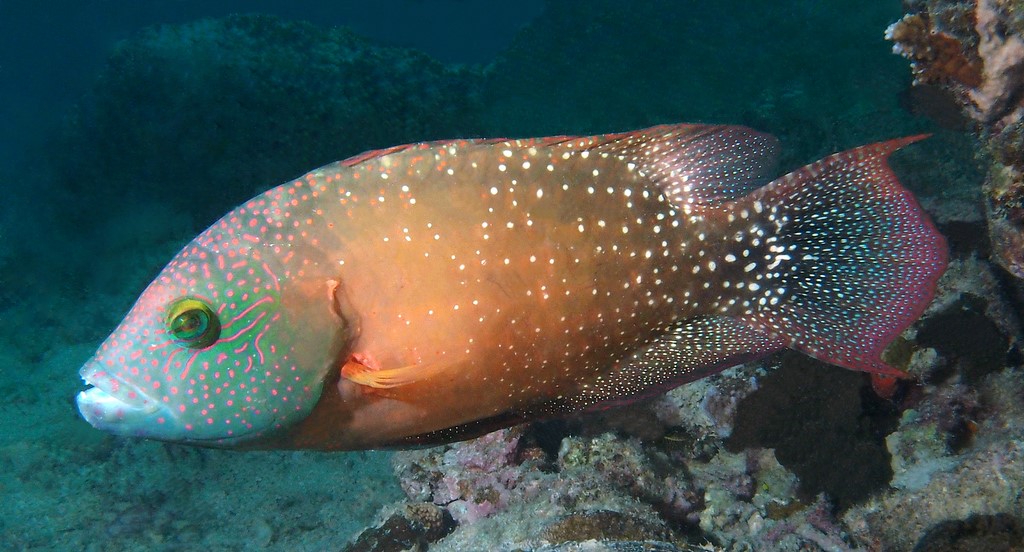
[{"left": 77, "top": 124, "right": 948, "bottom": 451}]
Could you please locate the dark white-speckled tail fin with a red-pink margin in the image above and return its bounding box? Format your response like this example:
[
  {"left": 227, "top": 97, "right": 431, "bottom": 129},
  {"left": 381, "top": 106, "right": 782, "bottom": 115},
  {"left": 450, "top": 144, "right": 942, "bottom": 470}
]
[{"left": 741, "top": 135, "right": 947, "bottom": 377}]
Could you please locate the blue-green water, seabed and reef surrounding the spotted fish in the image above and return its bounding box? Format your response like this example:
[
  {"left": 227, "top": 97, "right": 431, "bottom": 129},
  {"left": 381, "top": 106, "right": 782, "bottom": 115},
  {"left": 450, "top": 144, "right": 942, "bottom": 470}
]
[{"left": 0, "top": 0, "right": 1024, "bottom": 551}]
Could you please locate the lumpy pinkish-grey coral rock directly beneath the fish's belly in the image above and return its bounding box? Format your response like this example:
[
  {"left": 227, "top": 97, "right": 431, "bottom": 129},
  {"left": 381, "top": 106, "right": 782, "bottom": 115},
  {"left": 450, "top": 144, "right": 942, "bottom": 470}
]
[{"left": 387, "top": 389, "right": 901, "bottom": 551}]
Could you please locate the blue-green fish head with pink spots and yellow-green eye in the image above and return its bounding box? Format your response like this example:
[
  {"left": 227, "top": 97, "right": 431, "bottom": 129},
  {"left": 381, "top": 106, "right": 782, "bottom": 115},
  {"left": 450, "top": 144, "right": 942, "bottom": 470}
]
[{"left": 77, "top": 218, "right": 348, "bottom": 447}]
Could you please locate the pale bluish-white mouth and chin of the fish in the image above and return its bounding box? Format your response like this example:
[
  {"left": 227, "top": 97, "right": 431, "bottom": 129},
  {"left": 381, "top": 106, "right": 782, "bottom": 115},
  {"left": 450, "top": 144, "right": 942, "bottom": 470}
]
[{"left": 75, "top": 363, "right": 163, "bottom": 437}]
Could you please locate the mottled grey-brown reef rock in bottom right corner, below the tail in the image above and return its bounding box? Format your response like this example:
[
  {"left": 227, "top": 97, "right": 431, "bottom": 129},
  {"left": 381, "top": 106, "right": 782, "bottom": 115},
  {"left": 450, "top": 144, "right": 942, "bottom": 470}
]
[{"left": 843, "top": 352, "right": 1024, "bottom": 550}]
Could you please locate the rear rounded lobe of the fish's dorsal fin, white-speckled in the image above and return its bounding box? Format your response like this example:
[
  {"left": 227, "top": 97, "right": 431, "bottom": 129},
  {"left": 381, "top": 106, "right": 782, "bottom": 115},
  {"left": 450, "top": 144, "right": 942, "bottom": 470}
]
[{"left": 588, "top": 124, "right": 778, "bottom": 206}]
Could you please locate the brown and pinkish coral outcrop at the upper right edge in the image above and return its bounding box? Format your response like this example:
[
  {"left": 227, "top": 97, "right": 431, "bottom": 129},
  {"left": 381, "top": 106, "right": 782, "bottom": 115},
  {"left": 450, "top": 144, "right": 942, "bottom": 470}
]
[{"left": 886, "top": 0, "right": 1024, "bottom": 279}]
